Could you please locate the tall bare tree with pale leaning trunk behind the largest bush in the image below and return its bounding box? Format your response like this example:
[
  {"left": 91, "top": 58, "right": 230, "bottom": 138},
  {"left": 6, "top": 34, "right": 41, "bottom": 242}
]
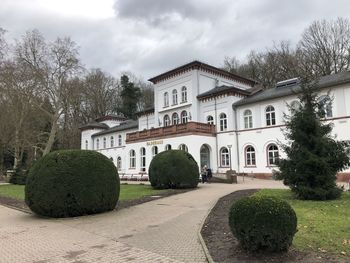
[{"left": 16, "top": 30, "right": 80, "bottom": 155}]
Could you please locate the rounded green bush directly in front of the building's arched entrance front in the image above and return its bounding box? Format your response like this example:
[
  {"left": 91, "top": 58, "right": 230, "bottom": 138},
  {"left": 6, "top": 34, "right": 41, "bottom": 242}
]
[{"left": 149, "top": 150, "right": 199, "bottom": 188}]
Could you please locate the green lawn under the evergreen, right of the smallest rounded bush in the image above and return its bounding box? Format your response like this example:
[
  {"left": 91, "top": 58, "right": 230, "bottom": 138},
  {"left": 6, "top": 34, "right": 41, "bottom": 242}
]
[{"left": 256, "top": 189, "right": 350, "bottom": 256}]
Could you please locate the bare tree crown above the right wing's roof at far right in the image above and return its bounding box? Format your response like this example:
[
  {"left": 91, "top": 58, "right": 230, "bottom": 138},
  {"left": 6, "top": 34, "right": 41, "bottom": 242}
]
[{"left": 298, "top": 18, "right": 350, "bottom": 76}]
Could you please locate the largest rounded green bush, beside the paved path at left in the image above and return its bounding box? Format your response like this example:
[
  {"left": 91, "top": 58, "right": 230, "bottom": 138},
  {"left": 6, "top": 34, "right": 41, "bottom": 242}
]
[{"left": 25, "top": 150, "right": 120, "bottom": 217}]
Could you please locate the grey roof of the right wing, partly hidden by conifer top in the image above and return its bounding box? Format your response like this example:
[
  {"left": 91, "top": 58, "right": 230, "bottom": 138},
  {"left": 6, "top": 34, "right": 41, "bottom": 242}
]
[{"left": 233, "top": 71, "right": 350, "bottom": 106}]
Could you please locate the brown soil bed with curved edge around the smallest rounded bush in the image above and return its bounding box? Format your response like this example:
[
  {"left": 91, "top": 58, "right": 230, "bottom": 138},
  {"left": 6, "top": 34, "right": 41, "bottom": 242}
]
[{"left": 201, "top": 189, "right": 349, "bottom": 263}]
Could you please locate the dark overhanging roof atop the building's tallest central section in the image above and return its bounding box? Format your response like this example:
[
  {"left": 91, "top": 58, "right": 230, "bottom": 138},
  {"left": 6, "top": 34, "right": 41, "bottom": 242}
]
[{"left": 149, "top": 60, "right": 257, "bottom": 86}]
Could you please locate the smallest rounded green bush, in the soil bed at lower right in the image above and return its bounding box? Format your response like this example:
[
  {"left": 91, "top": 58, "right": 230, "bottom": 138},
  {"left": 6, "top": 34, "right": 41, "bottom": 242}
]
[{"left": 229, "top": 196, "right": 297, "bottom": 251}]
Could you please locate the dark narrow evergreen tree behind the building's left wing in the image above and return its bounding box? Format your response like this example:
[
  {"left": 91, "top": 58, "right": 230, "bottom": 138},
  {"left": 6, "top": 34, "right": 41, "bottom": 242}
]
[{"left": 119, "top": 75, "right": 141, "bottom": 119}]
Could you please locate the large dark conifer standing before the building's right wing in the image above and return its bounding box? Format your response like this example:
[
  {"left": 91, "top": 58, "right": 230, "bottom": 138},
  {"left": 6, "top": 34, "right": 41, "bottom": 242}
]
[{"left": 278, "top": 82, "right": 350, "bottom": 200}]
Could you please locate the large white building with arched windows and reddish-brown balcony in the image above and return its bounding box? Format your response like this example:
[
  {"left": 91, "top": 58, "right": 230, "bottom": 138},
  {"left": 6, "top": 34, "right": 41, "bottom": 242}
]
[{"left": 81, "top": 61, "right": 350, "bottom": 183}]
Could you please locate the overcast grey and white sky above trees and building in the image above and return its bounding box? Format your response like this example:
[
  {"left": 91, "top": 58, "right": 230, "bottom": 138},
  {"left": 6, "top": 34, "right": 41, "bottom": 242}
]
[{"left": 0, "top": 0, "right": 350, "bottom": 79}]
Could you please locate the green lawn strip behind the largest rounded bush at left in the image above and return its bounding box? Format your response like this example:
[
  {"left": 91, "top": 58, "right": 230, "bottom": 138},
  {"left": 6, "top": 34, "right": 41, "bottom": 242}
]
[{"left": 0, "top": 184, "right": 168, "bottom": 203}]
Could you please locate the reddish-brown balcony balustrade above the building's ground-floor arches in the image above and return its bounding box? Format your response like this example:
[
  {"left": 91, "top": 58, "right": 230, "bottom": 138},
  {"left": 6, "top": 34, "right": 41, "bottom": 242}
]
[{"left": 126, "top": 122, "right": 215, "bottom": 143}]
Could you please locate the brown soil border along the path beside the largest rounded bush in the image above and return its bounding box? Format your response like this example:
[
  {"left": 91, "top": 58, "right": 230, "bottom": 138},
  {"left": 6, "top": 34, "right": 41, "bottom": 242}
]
[{"left": 0, "top": 189, "right": 191, "bottom": 214}]
